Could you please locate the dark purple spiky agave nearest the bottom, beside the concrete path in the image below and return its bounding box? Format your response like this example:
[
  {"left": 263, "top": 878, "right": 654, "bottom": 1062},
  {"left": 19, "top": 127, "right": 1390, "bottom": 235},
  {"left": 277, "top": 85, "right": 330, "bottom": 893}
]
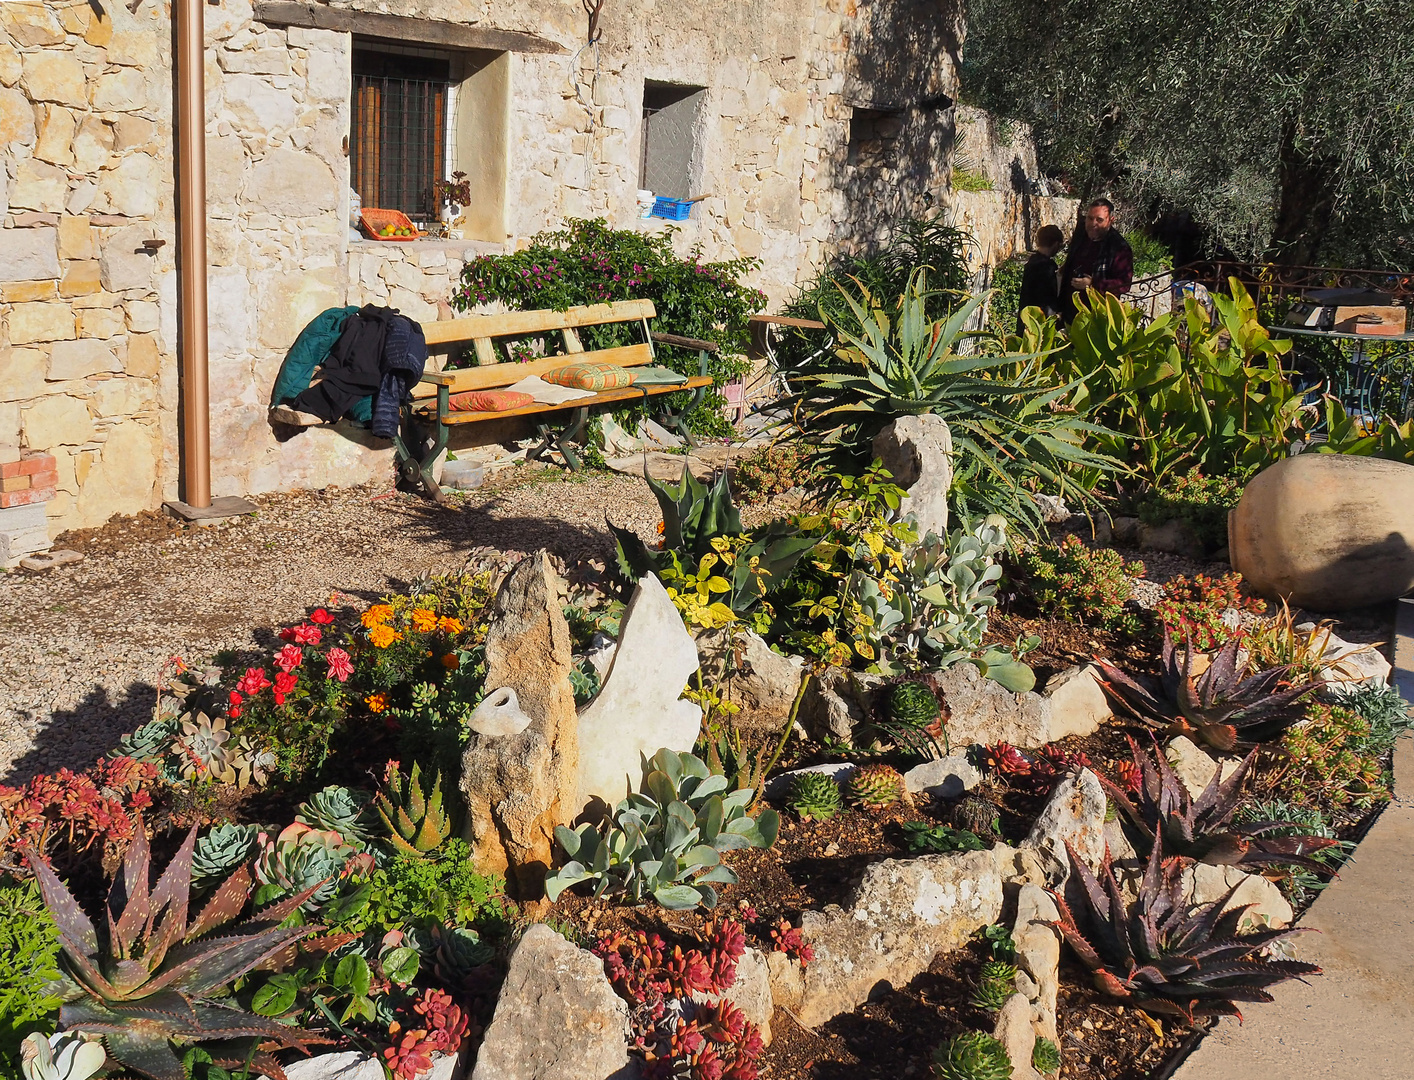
[{"left": 1052, "top": 838, "right": 1321, "bottom": 1023}]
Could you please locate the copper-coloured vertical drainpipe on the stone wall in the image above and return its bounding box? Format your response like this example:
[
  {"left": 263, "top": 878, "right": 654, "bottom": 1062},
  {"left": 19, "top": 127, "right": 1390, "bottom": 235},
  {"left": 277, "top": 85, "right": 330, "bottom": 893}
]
[{"left": 173, "top": 0, "right": 211, "bottom": 509}]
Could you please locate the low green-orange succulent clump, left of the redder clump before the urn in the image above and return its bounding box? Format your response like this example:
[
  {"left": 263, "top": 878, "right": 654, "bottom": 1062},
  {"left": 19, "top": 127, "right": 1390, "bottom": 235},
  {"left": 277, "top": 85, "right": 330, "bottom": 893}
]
[{"left": 1015, "top": 536, "right": 1144, "bottom": 635}]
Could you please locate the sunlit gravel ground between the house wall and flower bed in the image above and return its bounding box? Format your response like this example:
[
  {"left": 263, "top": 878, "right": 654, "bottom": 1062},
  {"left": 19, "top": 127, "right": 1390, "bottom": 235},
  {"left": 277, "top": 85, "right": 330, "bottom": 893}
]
[{"left": 0, "top": 468, "right": 662, "bottom": 785}]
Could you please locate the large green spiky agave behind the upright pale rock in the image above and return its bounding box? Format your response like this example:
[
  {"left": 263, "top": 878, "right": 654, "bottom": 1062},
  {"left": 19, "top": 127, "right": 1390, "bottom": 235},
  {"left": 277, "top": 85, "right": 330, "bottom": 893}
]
[{"left": 793, "top": 269, "right": 1118, "bottom": 532}]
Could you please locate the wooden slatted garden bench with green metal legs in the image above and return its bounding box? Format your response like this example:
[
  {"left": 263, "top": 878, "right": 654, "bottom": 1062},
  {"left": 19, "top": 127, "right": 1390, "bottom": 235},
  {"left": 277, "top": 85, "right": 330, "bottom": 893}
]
[{"left": 395, "top": 300, "right": 717, "bottom": 499}]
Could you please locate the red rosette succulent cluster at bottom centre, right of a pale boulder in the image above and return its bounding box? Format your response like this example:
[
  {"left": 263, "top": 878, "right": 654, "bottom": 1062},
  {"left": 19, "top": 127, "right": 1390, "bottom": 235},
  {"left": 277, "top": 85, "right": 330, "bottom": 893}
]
[{"left": 594, "top": 919, "right": 764, "bottom": 1080}]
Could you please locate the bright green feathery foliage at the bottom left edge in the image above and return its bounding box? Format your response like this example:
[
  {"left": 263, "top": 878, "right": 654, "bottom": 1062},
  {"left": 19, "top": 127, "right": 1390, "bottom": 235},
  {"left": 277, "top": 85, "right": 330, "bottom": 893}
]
[{"left": 0, "top": 881, "right": 61, "bottom": 1077}]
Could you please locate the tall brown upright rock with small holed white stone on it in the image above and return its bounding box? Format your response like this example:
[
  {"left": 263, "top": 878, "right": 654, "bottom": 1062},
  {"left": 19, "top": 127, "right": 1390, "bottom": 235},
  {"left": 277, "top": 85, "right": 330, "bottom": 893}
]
[{"left": 461, "top": 551, "right": 578, "bottom": 898}]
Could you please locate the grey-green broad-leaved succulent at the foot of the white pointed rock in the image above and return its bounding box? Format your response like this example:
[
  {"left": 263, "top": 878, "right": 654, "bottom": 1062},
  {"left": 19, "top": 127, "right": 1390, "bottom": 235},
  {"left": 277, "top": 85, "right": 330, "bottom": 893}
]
[{"left": 544, "top": 749, "right": 781, "bottom": 909}]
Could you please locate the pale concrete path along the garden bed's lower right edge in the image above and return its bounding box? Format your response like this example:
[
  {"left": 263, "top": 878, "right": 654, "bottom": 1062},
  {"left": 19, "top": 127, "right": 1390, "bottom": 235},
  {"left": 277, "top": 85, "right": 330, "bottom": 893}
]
[{"left": 1174, "top": 598, "right": 1414, "bottom": 1080}]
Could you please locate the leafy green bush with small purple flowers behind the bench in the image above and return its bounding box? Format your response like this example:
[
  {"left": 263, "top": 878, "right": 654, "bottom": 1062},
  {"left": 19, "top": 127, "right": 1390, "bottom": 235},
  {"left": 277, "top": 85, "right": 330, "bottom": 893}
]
[{"left": 452, "top": 218, "right": 766, "bottom": 435}]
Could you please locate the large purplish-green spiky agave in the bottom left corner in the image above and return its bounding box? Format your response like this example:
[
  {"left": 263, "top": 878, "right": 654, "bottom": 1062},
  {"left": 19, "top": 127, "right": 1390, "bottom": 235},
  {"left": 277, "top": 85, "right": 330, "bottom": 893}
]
[{"left": 27, "top": 827, "right": 317, "bottom": 1080}]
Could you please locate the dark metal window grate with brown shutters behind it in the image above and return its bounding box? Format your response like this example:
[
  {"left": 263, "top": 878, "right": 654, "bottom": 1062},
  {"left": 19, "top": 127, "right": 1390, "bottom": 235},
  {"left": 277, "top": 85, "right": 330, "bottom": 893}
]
[{"left": 349, "top": 52, "right": 451, "bottom": 221}]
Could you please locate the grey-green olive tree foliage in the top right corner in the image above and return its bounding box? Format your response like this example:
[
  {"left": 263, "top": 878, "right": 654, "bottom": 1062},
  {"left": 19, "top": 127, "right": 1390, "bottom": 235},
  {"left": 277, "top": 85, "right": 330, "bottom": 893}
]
[{"left": 963, "top": 0, "right": 1414, "bottom": 267}]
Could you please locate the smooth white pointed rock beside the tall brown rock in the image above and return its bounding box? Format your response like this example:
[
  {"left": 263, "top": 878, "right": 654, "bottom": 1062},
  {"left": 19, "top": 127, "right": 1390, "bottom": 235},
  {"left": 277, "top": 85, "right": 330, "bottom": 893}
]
[{"left": 574, "top": 574, "right": 703, "bottom": 814}]
